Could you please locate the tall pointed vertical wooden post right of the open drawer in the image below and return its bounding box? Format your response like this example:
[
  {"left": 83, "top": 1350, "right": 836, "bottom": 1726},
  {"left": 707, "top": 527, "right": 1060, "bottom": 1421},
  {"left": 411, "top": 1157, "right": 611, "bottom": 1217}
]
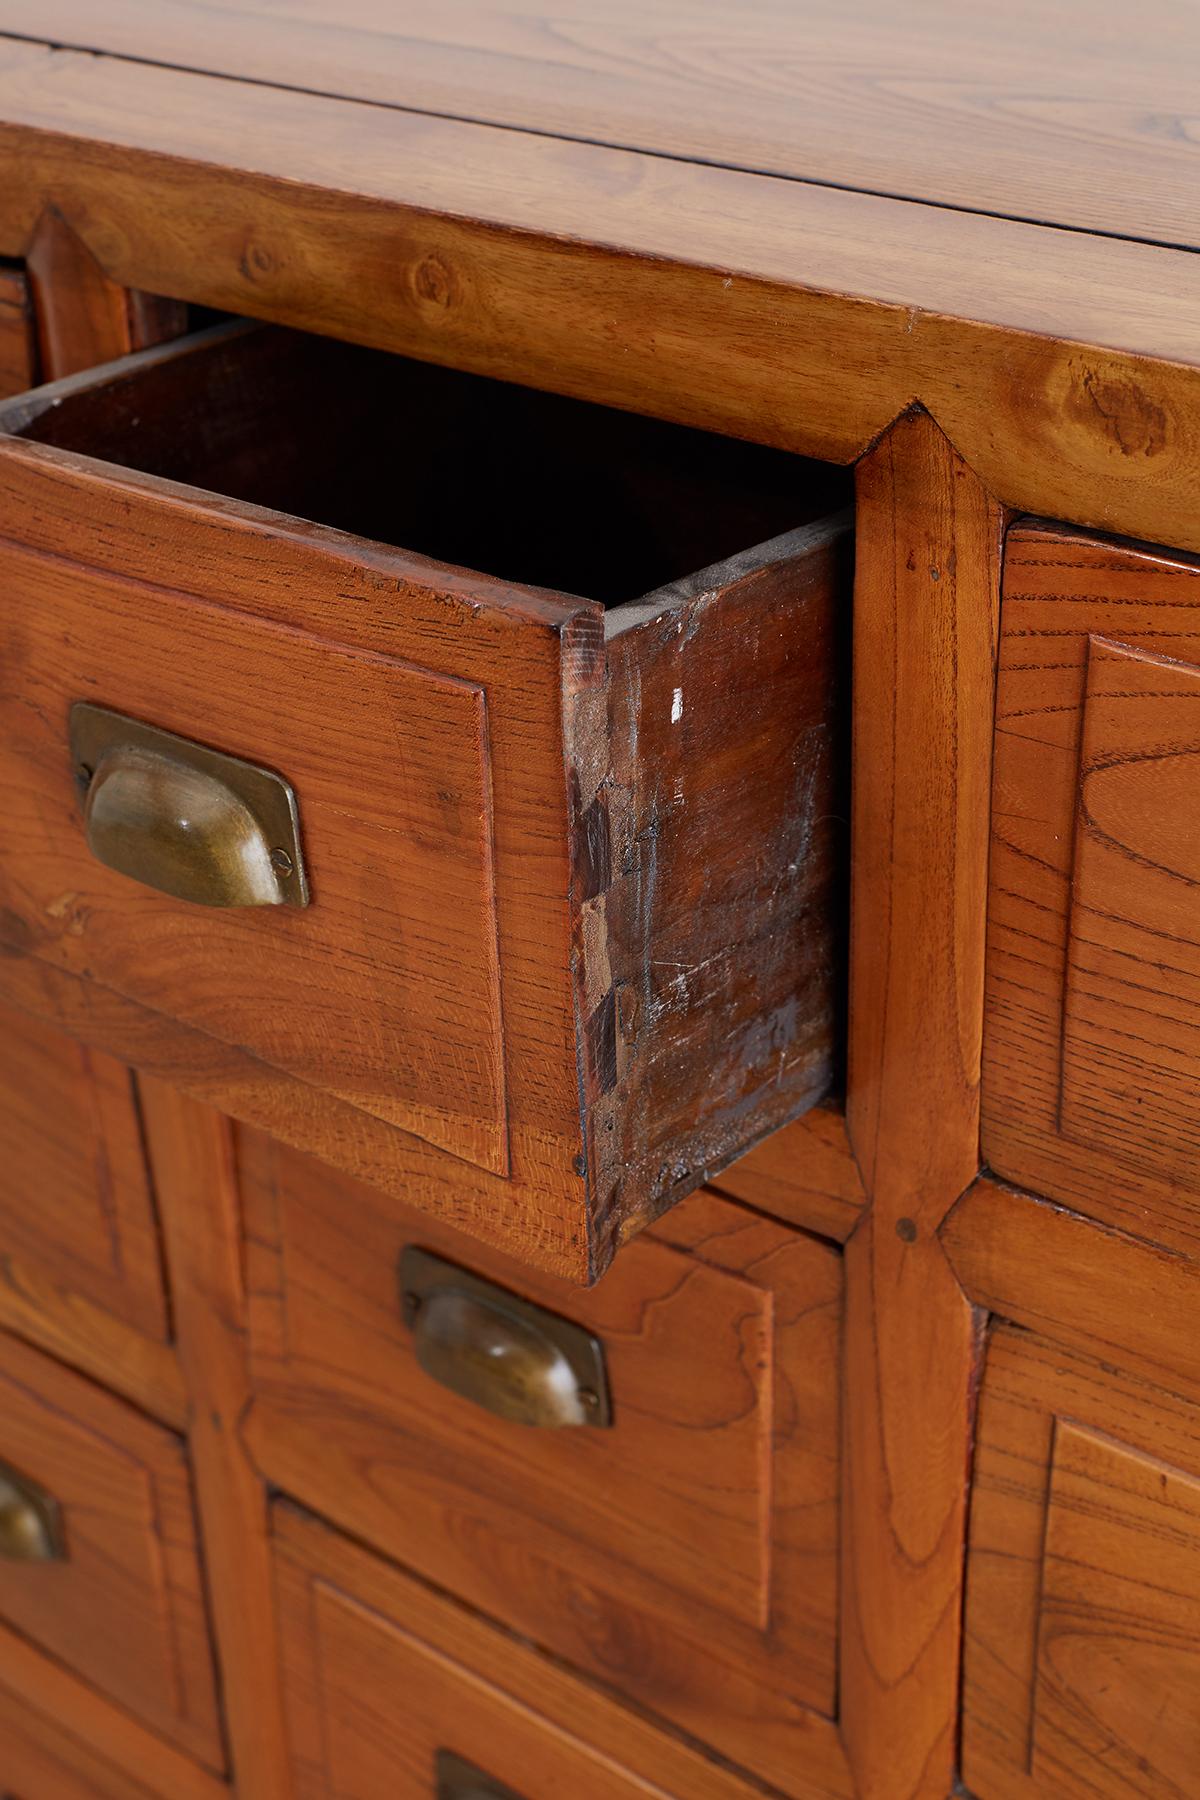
[{"left": 840, "top": 412, "right": 1002, "bottom": 1800}]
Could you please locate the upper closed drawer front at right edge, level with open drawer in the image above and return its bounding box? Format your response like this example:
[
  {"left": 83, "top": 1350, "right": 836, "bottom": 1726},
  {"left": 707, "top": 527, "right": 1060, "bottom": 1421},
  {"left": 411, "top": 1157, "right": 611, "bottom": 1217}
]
[{"left": 984, "top": 522, "right": 1200, "bottom": 1255}]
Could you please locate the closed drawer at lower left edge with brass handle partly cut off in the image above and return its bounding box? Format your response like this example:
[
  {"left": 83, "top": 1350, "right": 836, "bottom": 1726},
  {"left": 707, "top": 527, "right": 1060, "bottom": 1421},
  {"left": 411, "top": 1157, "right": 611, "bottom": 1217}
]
[{"left": 0, "top": 1337, "right": 223, "bottom": 1768}]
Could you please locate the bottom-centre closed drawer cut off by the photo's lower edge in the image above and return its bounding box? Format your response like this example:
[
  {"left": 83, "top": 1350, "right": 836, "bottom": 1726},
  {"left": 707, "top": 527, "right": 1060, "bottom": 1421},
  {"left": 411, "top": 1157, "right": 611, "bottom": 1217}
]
[{"left": 275, "top": 1503, "right": 819, "bottom": 1800}]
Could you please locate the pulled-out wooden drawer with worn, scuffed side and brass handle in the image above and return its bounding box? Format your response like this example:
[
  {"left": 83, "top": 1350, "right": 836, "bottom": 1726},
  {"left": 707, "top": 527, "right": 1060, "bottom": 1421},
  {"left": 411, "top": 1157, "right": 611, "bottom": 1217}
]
[{"left": 0, "top": 324, "right": 851, "bottom": 1280}]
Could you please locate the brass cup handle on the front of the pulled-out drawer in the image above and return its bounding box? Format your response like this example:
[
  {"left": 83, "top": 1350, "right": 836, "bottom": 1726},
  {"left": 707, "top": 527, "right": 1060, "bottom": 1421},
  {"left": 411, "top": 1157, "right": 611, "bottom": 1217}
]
[{"left": 70, "top": 702, "right": 308, "bottom": 907}]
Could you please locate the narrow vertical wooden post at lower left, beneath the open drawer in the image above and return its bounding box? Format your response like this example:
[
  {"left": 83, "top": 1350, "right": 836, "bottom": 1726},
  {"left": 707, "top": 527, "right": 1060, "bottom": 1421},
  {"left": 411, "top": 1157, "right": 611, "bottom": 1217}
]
[{"left": 142, "top": 1080, "right": 290, "bottom": 1800}]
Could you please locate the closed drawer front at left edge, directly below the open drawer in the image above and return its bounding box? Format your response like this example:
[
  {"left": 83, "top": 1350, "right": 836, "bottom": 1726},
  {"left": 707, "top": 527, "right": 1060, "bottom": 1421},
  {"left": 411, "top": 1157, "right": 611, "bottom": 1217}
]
[{"left": 0, "top": 1006, "right": 169, "bottom": 1339}]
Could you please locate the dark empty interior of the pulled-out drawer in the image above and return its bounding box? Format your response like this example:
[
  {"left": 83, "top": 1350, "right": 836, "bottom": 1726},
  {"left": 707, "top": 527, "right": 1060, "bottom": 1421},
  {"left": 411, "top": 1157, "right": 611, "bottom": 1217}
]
[{"left": 0, "top": 320, "right": 851, "bottom": 607}]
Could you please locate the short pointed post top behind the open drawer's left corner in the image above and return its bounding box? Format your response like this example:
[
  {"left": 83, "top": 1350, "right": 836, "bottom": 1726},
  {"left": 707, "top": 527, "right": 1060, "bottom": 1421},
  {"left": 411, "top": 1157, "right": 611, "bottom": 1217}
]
[{"left": 25, "top": 205, "right": 187, "bottom": 385}]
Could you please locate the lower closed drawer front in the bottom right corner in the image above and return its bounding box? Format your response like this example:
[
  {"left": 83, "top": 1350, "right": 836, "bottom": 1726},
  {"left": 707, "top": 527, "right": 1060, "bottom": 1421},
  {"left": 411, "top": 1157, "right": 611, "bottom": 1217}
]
[{"left": 963, "top": 1325, "right": 1200, "bottom": 1800}]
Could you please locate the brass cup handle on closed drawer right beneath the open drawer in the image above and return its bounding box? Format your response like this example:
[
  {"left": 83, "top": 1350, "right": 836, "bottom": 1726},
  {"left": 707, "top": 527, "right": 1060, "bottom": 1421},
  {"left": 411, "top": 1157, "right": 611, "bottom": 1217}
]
[{"left": 399, "top": 1246, "right": 612, "bottom": 1426}]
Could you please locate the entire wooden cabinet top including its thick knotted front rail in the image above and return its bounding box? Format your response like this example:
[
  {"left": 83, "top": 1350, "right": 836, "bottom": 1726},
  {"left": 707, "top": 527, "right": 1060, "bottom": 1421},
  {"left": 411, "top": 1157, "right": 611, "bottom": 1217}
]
[{"left": 0, "top": 17, "right": 1200, "bottom": 551}]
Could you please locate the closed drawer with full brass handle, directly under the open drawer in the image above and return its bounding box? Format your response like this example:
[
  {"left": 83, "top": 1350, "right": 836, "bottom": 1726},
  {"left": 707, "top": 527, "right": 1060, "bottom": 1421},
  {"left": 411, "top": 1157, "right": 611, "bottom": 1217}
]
[{"left": 239, "top": 1132, "right": 842, "bottom": 1793}]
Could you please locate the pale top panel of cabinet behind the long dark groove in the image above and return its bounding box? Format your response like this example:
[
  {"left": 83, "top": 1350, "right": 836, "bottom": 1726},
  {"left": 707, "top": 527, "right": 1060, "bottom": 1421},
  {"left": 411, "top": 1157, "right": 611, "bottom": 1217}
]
[{"left": 0, "top": 0, "right": 1200, "bottom": 248}]
